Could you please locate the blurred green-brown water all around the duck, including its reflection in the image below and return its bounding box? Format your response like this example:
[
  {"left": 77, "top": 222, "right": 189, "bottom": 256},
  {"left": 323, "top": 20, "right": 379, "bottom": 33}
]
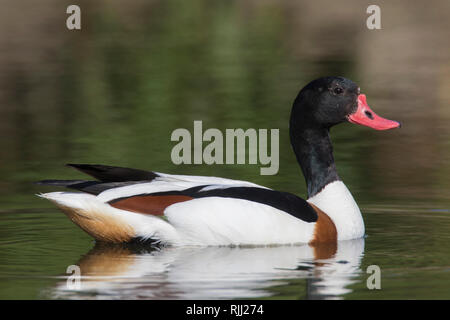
[{"left": 0, "top": 1, "right": 450, "bottom": 299}]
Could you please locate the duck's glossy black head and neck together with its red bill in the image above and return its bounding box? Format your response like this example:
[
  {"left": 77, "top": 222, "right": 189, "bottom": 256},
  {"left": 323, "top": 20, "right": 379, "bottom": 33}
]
[{"left": 289, "top": 77, "right": 400, "bottom": 197}]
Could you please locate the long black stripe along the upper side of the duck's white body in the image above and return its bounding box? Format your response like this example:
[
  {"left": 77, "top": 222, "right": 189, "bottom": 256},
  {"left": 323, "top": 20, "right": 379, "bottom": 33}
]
[{"left": 109, "top": 185, "right": 317, "bottom": 222}]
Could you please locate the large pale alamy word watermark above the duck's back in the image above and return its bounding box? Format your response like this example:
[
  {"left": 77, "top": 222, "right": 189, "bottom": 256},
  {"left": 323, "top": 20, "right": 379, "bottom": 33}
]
[{"left": 170, "top": 120, "right": 279, "bottom": 175}]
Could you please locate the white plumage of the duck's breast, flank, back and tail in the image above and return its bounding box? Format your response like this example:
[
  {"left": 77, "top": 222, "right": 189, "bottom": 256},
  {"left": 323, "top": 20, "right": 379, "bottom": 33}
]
[{"left": 41, "top": 174, "right": 364, "bottom": 246}]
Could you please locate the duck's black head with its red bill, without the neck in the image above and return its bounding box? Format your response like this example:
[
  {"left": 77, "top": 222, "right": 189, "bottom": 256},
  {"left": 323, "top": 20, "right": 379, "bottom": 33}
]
[{"left": 291, "top": 77, "right": 400, "bottom": 130}]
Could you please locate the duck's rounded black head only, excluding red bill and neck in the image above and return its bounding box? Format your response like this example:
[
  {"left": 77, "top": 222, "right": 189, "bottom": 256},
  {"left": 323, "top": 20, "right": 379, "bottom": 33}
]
[{"left": 291, "top": 77, "right": 359, "bottom": 128}]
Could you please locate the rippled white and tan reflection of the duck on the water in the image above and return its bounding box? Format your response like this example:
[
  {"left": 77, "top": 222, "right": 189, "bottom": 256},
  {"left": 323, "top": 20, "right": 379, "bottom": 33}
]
[{"left": 50, "top": 239, "right": 364, "bottom": 299}]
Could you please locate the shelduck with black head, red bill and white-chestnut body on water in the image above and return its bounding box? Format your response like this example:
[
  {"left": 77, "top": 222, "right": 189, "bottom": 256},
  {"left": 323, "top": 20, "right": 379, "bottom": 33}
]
[{"left": 38, "top": 76, "right": 401, "bottom": 247}]
